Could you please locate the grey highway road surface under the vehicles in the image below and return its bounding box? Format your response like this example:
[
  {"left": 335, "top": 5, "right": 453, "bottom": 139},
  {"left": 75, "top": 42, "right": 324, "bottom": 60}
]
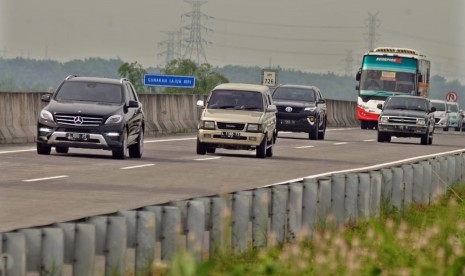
[{"left": 0, "top": 128, "right": 465, "bottom": 232}]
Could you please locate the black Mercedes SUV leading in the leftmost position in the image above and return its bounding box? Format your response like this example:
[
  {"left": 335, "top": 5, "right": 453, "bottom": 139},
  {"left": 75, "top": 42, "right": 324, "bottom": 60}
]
[{"left": 37, "top": 76, "right": 145, "bottom": 159}]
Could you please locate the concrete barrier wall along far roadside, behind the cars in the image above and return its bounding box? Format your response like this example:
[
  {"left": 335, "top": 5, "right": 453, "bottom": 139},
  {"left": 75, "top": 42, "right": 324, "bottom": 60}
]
[{"left": 0, "top": 92, "right": 359, "bottom": 144}]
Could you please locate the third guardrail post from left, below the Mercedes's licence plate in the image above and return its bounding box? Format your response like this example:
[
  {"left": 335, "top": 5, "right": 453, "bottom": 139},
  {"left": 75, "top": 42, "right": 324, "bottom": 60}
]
[{"left": 73, "top": 223, "right": 96, "bottom": 276}]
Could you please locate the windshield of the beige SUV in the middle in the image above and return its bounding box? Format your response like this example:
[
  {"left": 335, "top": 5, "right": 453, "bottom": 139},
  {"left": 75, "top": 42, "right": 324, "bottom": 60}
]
[{"left": 207, "top": 90, "right": 263, "bottom": 111}]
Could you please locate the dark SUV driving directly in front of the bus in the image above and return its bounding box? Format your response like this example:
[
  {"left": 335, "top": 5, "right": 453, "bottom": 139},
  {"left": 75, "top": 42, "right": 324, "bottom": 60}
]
[{"left": 378, "top": 95, "right": 436, "bottom": 145}]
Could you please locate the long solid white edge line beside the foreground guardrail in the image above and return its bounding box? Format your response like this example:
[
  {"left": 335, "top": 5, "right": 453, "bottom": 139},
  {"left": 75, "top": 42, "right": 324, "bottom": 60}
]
[{"left": 262, "top": 148, "right": 465, "bottom": 188}]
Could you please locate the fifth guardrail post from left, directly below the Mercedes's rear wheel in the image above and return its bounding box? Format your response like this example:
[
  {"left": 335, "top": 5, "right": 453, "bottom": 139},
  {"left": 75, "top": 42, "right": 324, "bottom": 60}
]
[{"left": 135, "top": 211, "right": 157, "bottom": 276}]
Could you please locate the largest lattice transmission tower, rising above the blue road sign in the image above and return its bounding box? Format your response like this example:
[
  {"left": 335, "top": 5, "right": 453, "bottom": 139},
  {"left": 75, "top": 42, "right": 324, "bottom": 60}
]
[{"left": 182, "top": 0, "right": 212, "bottom": 64}]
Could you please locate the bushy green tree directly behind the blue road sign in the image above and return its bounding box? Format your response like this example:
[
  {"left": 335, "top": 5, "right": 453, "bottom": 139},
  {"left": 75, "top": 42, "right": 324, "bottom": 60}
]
[{"left": 161, "top": 59, "right": 229, "bottom": 94}]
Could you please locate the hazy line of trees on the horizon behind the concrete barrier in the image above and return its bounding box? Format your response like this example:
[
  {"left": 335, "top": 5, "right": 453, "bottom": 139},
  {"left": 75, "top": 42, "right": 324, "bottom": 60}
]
[{"left": 0, "top": 58, "right": 465, "bottom": 106}]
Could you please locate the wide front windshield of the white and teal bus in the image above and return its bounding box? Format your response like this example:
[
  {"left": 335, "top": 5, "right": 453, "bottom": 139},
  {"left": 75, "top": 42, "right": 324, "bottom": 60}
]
[{"left": 360, "top": 70, "right": 415, "bottom": 95}]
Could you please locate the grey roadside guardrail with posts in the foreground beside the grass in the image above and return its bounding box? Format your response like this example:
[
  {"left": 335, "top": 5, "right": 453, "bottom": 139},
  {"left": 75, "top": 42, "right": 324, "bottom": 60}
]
[{"left": 0, "top": 150, "right": 465, "bottom": 276}]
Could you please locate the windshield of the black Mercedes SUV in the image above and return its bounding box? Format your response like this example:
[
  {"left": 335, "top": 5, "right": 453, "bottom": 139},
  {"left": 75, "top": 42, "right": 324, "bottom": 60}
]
[{"left": 55, "top": 82, "right": 123, "bottom": 104}]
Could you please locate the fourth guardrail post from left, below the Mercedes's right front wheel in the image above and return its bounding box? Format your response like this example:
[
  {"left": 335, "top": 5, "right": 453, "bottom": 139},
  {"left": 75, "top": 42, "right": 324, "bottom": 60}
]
[{"left": 105, "top": 216, "right": 128, "bottom": 276}]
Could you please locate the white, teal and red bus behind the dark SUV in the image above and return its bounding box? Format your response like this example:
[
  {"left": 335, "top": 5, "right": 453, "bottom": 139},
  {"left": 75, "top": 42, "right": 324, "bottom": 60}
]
[{"left": 356, "top": 47, "right": 430, "bottom": 129}]
